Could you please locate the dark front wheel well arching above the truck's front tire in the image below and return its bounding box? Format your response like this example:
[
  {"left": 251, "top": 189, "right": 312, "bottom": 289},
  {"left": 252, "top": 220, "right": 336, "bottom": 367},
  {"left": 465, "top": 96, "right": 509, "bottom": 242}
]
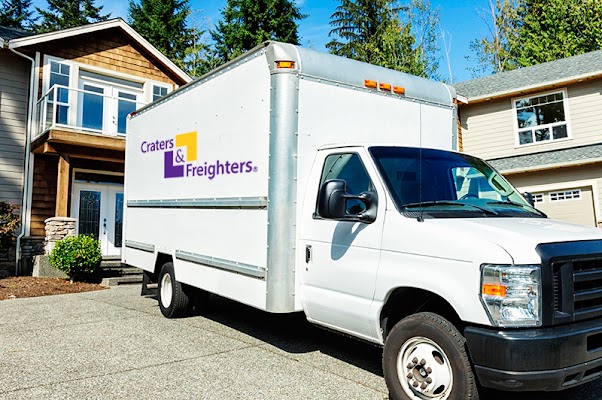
[{"left": 380, "top": 288, "right": 463, "bottom": 339}]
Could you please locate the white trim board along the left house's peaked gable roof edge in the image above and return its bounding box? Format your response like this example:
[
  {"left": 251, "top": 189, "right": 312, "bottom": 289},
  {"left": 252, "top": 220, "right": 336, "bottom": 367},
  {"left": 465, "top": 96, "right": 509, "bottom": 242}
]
[{"left": 8, "top": 18, "right": 192, "bottom": 83}]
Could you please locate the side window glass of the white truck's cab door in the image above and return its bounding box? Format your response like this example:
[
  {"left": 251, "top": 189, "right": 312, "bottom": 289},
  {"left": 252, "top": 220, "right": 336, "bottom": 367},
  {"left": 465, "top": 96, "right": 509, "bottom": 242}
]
[{"left": 320, "top": 153, "right": 374, "bottom": 214}]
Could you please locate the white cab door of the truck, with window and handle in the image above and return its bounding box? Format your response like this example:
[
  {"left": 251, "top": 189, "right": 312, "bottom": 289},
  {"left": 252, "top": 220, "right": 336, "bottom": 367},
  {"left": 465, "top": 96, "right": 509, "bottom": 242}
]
[{"left": 299, "top": 148, "right": 386, "bottom": 338}]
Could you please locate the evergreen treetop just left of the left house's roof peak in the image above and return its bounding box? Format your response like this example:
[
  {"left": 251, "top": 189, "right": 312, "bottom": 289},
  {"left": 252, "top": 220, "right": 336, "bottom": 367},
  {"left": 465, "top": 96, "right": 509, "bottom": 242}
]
[{"left": 36, "top": 0, "right": 110, "bottom": 32}]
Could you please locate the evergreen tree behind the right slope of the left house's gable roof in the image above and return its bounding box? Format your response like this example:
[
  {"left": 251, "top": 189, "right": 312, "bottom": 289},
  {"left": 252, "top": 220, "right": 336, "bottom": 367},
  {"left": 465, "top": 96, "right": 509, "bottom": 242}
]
[{"left": 128, "top": 0, "right": 196, "bottom": 67}]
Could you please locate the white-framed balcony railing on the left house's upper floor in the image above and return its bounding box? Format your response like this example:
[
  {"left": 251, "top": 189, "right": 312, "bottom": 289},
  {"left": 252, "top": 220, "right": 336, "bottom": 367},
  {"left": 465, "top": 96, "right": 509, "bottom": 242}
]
[{"left": 36, "top": 85, "right": 144, "bottom": 136}]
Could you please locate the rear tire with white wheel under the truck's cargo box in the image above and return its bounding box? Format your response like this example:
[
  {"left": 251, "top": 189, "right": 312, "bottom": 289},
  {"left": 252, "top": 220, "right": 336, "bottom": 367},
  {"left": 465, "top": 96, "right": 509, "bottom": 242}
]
[{"left": 158, "top": 262, "right": 193, "bottom": 318}]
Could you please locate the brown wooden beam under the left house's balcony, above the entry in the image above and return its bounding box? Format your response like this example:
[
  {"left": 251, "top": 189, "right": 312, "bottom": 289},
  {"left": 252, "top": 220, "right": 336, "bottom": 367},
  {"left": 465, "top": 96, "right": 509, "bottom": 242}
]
[{"left": 31, "top": 128, "right": 125, "bottom": 163}]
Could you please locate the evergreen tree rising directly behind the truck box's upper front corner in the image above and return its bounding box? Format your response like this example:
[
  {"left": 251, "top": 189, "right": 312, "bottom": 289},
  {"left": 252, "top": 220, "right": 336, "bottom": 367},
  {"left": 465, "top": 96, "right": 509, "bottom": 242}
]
[{"left": 211, "top": 0, "right": 306, "bottom": 62}]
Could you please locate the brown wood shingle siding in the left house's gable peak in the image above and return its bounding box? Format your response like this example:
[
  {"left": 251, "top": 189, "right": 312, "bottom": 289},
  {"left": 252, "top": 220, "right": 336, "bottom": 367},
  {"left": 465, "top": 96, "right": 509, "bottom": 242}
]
[{"left": 29, "top": 28, "right": 184, "bottom": 87}]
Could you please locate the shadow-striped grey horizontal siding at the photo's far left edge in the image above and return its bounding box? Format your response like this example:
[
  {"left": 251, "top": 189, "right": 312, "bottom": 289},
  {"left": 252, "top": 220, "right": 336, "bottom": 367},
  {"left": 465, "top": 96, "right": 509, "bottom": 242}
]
[{"left": 0, "top": 50, "right": 31, "bottom": 205}]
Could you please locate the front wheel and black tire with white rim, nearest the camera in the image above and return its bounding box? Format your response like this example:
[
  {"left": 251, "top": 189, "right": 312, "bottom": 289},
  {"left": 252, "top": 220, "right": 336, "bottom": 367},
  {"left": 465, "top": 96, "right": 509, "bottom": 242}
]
[{"left": 383, "top": 313, "right": 479, "bottom": 400}]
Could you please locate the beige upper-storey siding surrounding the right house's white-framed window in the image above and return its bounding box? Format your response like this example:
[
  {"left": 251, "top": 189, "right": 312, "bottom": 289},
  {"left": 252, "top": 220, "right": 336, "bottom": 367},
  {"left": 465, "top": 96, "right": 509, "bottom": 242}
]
[{"left": 461, "top": 80, "right": 602, "bottom": 159}]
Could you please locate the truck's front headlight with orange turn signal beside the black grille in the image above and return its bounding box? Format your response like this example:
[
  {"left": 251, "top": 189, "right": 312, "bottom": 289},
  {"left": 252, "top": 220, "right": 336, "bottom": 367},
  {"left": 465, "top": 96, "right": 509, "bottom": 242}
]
[{"left": 481, "top": 264, "right": 541, "bottom": 327}]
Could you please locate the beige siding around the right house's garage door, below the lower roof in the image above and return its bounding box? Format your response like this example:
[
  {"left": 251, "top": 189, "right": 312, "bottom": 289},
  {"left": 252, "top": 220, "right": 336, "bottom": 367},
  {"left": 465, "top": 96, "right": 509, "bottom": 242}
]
[{"left": 506, "top": 164, "right": 602, "bottom": 226}]
